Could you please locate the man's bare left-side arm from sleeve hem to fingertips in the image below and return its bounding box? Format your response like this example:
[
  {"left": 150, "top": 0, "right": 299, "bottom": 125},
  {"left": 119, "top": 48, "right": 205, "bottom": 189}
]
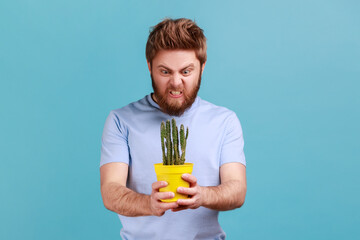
[{"left": 100, "top": 162, "right": 178, "bottom": 217}]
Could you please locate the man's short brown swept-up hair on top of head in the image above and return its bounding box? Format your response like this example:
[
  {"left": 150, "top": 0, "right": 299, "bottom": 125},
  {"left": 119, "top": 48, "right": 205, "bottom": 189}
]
[{"left": 146, "top": 18, "right": 206, "bottom": 66}]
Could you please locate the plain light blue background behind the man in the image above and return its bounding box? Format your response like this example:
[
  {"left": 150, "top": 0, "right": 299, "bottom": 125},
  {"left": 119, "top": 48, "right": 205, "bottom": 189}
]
[{"left": 0, "top": 0, "right": 360, "bottom": 240}]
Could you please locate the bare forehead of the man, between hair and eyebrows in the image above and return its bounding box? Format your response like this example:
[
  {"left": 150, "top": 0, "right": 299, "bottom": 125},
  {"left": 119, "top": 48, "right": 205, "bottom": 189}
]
[{"left": 152, "top": 49, "right": 200, "bottom": 69}]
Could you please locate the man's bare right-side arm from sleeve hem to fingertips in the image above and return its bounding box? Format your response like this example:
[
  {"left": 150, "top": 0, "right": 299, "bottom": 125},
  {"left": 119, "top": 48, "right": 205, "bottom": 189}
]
[{"left": 174, "top": 163, "right": 246, "bottom": 211}]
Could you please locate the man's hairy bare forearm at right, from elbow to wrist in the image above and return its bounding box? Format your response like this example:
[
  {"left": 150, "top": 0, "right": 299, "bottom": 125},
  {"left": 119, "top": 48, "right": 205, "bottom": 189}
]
[{"left": 202, "top": 180, "right": 246, "bottom": 211}]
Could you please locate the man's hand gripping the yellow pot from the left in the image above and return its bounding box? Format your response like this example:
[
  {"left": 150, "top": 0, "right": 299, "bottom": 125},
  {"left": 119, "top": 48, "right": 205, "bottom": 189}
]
[{"left": 150, "top": 181, "right": 178, "bottom": 217}]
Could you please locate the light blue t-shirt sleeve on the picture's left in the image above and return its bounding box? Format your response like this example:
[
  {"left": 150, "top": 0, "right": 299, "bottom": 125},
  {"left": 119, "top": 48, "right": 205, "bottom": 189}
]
[{"left": 100, "top": 111, "right": 129, "bottom": 167}]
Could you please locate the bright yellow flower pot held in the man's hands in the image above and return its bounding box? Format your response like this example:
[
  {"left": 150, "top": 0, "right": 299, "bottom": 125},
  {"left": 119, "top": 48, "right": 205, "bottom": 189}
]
[{"left": 154, "top": 163, "right": 193, "bottom": 202}]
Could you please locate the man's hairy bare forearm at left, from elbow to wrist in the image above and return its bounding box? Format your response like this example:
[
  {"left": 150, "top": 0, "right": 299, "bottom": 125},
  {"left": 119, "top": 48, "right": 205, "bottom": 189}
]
[{"left": 101, "top": 183, "right": 151, "bottom": 217}]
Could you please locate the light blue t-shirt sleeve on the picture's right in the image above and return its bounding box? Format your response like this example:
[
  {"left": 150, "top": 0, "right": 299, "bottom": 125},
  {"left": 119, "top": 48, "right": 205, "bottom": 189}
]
[{"left": 220, "top": 112, "right": 246, "bottom": 166}]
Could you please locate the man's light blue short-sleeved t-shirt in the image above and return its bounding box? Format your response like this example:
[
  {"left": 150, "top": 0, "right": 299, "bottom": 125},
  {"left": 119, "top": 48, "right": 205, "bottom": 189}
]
[{"left": 100, "top": 94, "right": 246, "bottom": 240}]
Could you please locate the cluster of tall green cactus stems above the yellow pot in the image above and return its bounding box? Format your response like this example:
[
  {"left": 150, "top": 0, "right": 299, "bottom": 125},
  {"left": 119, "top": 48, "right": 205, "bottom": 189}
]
[{"left": 160, "top": 119, "right": 189, "bottom": 165}]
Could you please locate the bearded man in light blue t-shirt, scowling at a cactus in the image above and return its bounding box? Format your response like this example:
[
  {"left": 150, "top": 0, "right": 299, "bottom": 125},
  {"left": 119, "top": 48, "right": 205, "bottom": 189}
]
[{"left": 100, "top": 19, "right": 246, "bottom": 240}]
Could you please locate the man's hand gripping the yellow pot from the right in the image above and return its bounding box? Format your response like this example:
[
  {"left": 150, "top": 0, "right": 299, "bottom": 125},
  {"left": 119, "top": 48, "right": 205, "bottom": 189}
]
[{"left": 172, "top": 174, "right": 203, "bottom": 212}]
